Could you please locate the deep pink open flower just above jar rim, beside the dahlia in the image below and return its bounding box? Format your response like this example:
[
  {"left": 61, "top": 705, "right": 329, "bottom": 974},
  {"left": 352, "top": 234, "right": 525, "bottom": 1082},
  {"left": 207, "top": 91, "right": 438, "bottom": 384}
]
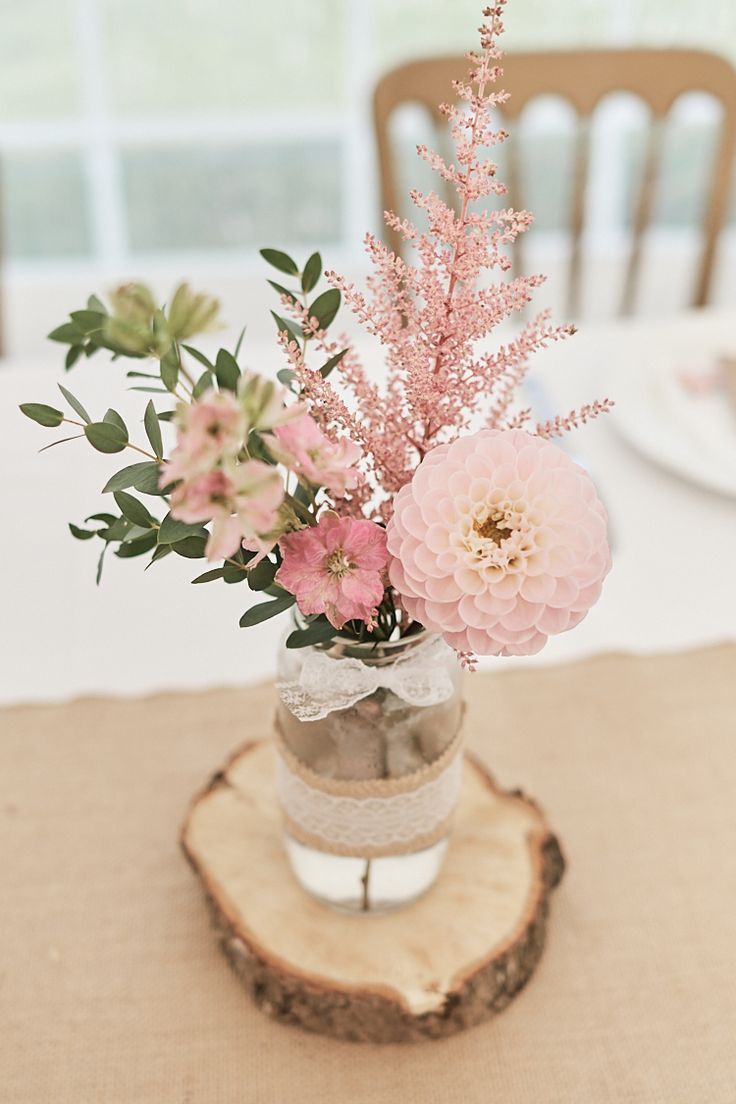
[{"left": 276, "top": 510, "right": 388, "bottom": 628}]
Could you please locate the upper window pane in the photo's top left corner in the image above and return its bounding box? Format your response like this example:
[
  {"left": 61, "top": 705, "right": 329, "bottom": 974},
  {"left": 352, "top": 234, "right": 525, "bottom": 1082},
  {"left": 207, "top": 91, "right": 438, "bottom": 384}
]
[{"left": 0, "top": 0, "right": 79, "bottom": 123}]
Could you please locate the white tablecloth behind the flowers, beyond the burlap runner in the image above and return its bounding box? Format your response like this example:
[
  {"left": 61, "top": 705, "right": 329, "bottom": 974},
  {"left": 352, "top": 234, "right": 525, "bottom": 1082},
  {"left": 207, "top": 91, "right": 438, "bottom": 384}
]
[{"left": 0, "top": 311, "right": 736, "bottom": 701}]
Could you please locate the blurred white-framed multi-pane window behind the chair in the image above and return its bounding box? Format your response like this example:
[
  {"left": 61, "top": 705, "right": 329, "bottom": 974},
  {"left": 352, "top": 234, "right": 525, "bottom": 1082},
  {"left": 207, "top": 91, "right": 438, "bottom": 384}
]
[{"left": 0, "top": 0, "right": 736, "bottom": 293}]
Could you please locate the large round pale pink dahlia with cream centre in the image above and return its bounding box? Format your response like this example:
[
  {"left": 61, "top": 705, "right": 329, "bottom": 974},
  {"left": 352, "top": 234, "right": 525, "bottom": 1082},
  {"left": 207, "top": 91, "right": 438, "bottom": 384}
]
[{"left": 387, "top": 429, "right": 610, "bottom": 656}]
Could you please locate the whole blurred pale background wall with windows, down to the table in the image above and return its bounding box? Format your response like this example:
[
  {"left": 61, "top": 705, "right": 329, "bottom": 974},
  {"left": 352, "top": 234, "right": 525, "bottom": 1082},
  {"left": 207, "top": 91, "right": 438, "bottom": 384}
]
[{"left": 0, "top": 0, "right": 736, "bottom": 355}]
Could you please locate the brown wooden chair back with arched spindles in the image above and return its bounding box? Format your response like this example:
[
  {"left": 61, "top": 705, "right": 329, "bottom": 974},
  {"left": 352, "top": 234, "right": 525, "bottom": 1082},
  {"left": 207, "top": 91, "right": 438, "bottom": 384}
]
[{"left": 373, "top": 50, "right": 736, "bottom": 315}]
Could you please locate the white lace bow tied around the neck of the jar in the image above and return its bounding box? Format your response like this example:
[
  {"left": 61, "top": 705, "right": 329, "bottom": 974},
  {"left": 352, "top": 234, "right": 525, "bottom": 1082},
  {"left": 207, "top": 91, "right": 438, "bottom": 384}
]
[{"left": 277, "top": 639, "right": 455, "bottom": 721}]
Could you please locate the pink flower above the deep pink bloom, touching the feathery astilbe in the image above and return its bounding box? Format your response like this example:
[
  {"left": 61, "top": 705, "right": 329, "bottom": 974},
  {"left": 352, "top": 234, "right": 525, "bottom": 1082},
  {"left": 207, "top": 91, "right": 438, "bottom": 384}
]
[{"left": 271, "top": 414, "right": 362, "bottom": 498}]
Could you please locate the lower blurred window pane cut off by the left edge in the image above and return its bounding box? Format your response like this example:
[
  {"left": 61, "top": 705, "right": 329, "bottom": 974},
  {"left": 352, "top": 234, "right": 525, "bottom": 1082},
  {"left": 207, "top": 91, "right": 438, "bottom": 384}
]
[{"left": 2, "top": 151, "right": 92, "bottom": 257}]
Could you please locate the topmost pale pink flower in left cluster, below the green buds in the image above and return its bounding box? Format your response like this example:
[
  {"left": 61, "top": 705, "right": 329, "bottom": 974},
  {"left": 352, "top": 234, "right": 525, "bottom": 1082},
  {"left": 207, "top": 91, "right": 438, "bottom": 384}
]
[{"left": 160, "top": 389, "right": 248, "bottom": 487}]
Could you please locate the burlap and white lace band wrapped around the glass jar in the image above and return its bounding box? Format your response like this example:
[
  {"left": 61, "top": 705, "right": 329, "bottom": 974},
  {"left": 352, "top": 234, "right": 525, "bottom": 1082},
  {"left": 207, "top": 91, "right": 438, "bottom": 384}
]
[{"left": 276, "top": 745, "right": 462, "bottom": 858}]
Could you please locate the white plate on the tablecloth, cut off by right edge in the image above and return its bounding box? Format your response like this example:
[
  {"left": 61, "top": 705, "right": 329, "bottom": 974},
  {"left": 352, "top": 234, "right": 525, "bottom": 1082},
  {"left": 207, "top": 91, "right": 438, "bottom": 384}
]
[{"left": 610, "top": 341, "right": 736, "bottom": 501}]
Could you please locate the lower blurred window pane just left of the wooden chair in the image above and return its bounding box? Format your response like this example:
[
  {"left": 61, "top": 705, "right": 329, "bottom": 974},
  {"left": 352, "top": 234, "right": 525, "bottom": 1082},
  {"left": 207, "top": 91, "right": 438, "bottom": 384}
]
[{"left": 122, "top": 141, "right": 342, "bottom": 252}]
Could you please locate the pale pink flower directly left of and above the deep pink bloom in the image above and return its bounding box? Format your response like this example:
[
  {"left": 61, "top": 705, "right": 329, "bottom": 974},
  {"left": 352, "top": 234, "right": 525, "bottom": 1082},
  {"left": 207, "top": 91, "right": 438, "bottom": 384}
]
[{"left": 171, "top": 460, "right": 284, "bottom": 560}]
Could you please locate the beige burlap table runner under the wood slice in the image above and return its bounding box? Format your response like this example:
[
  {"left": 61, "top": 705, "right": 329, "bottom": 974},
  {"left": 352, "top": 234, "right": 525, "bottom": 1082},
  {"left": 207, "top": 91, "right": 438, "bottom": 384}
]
[{"left": 0, "top": 646, "right": 736, "bottom": 1104}]
